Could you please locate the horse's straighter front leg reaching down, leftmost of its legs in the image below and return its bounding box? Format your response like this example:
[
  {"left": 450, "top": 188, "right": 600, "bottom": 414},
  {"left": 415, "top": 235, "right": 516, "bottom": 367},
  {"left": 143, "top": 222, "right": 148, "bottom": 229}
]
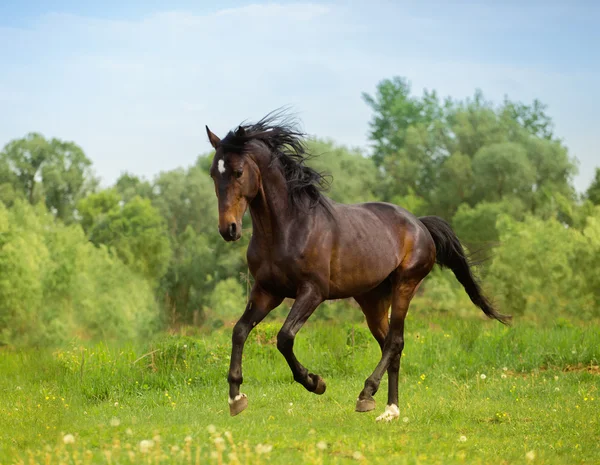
[{"left": 227, "top": 284, "right": 283, "bottom": 416}]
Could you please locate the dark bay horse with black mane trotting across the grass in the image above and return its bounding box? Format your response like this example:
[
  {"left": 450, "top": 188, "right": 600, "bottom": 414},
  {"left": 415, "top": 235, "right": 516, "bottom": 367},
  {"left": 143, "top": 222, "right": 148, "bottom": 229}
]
[{"left": 206, "top": 112, "right": 511, "bottom": 421}]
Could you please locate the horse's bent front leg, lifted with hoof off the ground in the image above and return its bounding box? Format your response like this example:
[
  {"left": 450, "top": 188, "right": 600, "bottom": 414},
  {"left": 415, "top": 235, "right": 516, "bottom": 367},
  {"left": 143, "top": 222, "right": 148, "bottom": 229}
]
[{"left": 277, "top": 285, "right": 325, "bottom": 394}]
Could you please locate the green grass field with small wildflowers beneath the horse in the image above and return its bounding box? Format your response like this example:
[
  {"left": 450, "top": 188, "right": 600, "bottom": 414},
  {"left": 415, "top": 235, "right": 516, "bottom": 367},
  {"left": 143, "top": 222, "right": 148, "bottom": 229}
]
[{"left": 0, "top": 318, "right": 600, "bottom": 465}]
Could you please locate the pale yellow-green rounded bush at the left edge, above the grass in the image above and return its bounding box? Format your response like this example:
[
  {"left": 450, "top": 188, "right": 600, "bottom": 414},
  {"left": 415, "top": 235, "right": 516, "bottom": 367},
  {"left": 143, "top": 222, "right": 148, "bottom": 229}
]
[{"left": 0, "top": 201, "right": 158, "bottom": 345}]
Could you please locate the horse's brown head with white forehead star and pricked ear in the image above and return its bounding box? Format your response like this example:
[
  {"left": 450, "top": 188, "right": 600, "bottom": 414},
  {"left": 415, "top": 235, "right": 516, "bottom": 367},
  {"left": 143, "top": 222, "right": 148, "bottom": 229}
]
[{"left": 206, "top": 127, "right": 260, "bottom": 241}]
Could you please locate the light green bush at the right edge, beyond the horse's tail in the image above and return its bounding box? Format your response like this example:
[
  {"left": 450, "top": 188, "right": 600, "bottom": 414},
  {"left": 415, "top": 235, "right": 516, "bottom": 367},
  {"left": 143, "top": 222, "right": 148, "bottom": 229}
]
[{"left": 489, "top": 209, "right": 600, "bottom": 320}]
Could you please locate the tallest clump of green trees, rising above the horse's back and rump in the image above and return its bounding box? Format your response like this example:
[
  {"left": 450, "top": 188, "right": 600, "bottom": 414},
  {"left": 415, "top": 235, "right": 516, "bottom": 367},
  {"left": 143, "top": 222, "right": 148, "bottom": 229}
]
[{"left": 364, "top": 78, "right": 576, "bottom": 218}]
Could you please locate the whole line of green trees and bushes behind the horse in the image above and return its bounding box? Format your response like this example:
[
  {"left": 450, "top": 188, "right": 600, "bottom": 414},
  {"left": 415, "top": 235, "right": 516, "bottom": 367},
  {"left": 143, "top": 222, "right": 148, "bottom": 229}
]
[{"left": 0, "top": 77, "right": 600, "bottom": 344}]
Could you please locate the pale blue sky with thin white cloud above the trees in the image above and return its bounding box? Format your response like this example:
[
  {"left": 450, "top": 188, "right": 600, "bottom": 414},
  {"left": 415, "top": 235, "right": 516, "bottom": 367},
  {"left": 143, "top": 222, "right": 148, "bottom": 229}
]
[{"left": 0, "top": 0, "right": 600, "bottom": 191}]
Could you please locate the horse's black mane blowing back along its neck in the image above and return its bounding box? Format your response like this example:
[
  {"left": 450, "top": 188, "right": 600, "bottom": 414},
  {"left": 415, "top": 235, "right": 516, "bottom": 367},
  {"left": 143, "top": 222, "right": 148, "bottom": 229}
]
[{"left": 221, "top": 110, "right": 331, "bottom": 208}]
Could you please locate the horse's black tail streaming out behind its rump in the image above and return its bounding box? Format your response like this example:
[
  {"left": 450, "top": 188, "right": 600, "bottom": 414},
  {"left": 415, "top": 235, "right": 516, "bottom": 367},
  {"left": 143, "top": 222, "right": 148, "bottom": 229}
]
[{"left": 419, "top": 216, "right": 512, "bottom": 325}]
